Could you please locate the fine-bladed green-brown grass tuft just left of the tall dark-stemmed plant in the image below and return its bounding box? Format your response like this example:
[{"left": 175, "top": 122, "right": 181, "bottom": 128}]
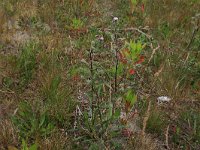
[{"left": 41, "top": 71, "right": 75, "bottom": 127}]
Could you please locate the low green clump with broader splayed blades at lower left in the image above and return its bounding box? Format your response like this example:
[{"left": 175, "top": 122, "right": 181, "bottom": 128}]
[{"left": 12, "top": 101, "right": 54, "bottom": 141}]
